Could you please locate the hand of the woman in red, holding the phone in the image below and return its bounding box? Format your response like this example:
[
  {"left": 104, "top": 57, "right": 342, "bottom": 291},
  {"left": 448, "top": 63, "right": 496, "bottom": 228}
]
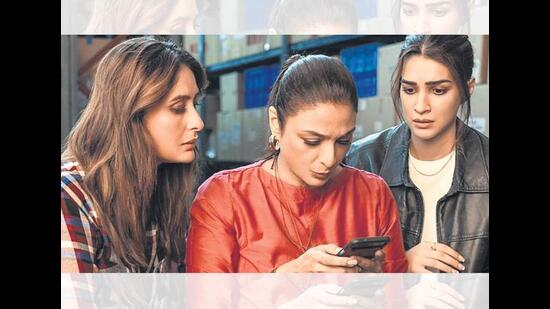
[{"left": 275, "top": 244, "right": 362, "bottom": 273}]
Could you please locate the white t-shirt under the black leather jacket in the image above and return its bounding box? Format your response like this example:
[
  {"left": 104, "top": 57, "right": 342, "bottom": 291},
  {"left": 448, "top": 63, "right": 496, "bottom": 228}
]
[{"left": 409, "top": 149, "right": 455, "bottom": 242}]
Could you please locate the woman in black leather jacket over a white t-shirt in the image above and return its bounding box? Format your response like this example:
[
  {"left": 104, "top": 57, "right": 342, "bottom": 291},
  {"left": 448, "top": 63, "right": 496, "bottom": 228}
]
[{"left": 347, "top": 35, "right": 489, "bottom": 272}]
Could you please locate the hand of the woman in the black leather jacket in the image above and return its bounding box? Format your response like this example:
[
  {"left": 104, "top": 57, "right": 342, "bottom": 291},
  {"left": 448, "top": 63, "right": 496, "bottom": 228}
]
[{"left": 405, "top": 242, "right": 464, "bottom": 273}]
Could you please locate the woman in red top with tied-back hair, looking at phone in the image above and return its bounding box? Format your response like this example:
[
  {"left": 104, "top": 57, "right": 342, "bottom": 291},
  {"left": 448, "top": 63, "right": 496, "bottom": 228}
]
[{"left": 186, "top": 55, "right": 407, "bottom": 272}]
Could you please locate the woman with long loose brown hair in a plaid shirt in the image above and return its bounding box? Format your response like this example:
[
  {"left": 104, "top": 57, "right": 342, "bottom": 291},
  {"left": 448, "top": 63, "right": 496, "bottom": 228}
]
[{"left": 61, "top": 38, "right": 208, "bottom": 272}]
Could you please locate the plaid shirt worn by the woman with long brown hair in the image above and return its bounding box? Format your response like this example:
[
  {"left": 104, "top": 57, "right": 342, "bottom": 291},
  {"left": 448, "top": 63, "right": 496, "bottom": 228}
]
[{"left": 61, "top": 161, "right": 168, "bottom": 272}]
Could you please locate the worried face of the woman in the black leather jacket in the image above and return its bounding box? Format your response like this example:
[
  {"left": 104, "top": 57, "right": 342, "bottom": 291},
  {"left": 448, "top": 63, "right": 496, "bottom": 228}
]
[{"left": 400, "top": 55, "right": 473, "bottom": 141}]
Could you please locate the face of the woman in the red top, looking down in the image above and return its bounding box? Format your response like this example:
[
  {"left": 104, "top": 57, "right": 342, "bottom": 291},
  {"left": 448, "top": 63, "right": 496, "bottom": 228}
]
[{"left": 270, "top": 103, "right": 357, "bottom": 187}]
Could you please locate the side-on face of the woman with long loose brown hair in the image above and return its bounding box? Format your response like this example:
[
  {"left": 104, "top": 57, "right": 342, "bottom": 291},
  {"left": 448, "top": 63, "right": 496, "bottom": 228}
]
[{"left": 144, "top": 66, "right": 204, "bottom": 163}]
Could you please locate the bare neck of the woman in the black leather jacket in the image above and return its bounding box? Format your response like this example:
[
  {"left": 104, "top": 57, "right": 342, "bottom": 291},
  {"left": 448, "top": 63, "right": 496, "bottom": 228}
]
[{"left": 409, "top": 126, "right": 456, "bottom": 161}]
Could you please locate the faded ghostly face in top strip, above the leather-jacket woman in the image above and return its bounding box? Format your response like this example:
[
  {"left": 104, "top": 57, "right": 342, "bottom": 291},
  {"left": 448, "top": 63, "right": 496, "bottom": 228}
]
[{"left": 399, "top": 0, "right": 469, "bottom": 34}]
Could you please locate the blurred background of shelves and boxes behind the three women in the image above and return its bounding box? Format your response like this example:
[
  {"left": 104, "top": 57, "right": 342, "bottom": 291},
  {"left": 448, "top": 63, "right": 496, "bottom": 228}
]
[{"left": 61, "top": 35, "right": 489, "bottom": 177}]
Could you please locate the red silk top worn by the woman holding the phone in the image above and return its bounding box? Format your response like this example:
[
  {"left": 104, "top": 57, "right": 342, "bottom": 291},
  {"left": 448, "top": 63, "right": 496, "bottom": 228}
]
[{"left": 186, "top": 161, "right": 407, "bottom": 272}]
